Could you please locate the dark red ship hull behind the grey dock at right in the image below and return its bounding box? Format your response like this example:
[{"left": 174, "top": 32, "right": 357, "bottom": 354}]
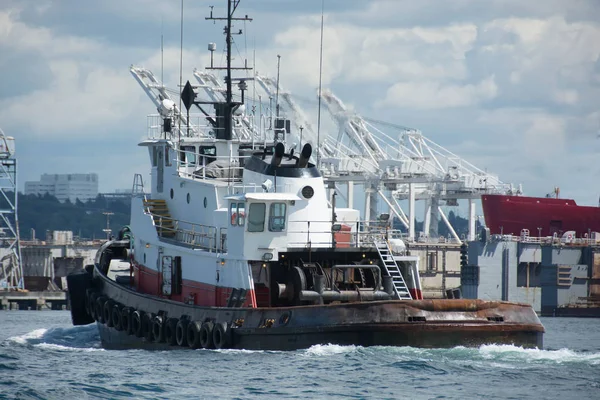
[{"left": 481, "top": 195, "right": 600, "bottom": 237}]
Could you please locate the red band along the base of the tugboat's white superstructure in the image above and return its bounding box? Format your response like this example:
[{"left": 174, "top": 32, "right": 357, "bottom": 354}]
[{"left": 133, "top": 264, "right": 256, "bottom": 308}]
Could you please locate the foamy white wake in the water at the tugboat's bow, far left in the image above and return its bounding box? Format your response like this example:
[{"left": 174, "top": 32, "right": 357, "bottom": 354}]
[{"left": 6, "top": 325, "right": 103, "bottom": 351}]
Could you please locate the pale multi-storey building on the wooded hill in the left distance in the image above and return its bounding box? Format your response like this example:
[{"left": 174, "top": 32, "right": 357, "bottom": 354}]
[{"left": 25, "top": 174, "right": 98, "bottom": 203}]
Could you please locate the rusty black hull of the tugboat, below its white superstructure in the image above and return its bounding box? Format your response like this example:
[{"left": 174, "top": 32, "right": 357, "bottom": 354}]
[{"left": 69, "top": 268, "right": 544, "bottom": 350}]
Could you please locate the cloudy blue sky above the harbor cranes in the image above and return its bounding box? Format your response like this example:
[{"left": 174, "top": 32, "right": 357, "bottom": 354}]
[{"left": 0, "top": 0, "right": 600, "bottom": 205}]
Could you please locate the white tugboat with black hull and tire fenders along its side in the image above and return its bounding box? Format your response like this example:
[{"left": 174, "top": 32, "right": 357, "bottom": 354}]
[{"left": 68, "top": 0, "right": 544, "bottom": 350}]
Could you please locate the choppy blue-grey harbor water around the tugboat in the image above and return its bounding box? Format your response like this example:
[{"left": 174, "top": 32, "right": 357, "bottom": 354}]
[{"left": 0, "top": 311, "right": 600, "bottom": 399}]
